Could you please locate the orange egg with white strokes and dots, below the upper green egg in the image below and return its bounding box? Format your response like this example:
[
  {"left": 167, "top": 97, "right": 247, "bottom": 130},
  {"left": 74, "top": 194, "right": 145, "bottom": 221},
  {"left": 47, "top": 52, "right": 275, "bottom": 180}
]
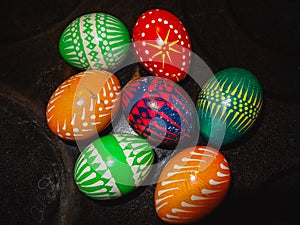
[{"left": 46, "top": 70, "right": 121, "bottom": 141}]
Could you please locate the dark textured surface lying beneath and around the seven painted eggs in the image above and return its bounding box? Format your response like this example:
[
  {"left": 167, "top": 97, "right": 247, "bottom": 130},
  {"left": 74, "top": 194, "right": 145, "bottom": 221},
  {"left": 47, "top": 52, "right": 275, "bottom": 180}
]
[{"left": 0, "top": 0, "right": 300, "bottom": 225}]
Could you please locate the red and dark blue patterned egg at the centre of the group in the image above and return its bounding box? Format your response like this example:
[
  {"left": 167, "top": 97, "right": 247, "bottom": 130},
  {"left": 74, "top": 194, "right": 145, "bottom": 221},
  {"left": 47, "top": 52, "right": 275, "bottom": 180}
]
[{"left": 122, "top": 76, "right": 198, "bottom": 146}]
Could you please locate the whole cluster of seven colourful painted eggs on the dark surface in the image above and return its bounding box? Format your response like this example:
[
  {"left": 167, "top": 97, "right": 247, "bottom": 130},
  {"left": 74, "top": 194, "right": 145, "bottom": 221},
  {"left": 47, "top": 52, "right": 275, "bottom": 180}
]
[{"left": 46, "top": 9, "right": 262, "bottom": 224}]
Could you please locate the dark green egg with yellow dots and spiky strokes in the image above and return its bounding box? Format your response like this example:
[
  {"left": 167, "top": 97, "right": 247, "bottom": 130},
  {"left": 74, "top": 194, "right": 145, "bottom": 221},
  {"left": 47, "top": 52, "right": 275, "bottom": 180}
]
[{"left": 197, "top": 68, "right": 263, "bottom": 145}]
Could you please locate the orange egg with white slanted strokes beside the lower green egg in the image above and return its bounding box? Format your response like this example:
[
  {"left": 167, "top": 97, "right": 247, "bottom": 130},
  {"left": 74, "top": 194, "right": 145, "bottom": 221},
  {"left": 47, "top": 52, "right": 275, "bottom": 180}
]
[{"left": 154, "top": 146, "right": 230, "bottom": 224}]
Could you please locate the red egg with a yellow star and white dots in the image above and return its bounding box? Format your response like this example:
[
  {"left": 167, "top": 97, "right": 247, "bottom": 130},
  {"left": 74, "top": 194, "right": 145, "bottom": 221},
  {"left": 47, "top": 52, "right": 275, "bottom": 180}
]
[{"left": 132, "top": 9, "right": 191, "bottom": 82}]
